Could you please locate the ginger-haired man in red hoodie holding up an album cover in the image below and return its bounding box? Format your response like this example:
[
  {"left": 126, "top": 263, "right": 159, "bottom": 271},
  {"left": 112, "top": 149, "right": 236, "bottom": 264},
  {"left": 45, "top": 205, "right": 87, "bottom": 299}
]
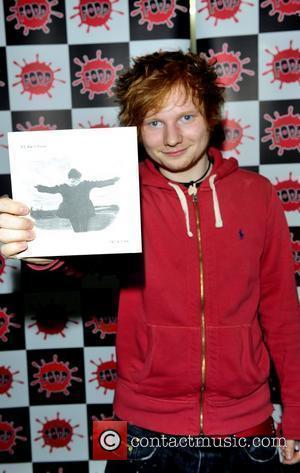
[{"left": 0, "top": 51, "right": 300, "bottom": 473}]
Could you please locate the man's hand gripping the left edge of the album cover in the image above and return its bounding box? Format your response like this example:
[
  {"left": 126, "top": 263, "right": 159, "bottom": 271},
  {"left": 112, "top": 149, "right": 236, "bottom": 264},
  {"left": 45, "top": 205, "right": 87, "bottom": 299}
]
[{"left": 0, "top": 196, "right": 35, "bottom": 258}]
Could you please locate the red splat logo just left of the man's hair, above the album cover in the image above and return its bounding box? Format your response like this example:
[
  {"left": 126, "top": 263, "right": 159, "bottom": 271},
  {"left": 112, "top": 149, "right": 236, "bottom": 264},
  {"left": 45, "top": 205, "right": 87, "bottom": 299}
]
[{"left": 72, "top": 49, "right": 123, "bottom": 100}]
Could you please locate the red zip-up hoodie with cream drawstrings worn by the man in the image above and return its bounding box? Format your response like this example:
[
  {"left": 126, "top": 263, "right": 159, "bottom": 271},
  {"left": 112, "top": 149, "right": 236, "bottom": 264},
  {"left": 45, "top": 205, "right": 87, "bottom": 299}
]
[{"left": 114, "top": 149, "right": 300, "bottom": 439}]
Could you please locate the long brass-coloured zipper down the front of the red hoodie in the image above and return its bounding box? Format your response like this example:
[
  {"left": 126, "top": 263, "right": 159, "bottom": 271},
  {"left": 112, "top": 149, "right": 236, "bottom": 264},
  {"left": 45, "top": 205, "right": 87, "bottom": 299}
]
[{"left": 193, "top": 193, "right": 206, "bottom": 434}]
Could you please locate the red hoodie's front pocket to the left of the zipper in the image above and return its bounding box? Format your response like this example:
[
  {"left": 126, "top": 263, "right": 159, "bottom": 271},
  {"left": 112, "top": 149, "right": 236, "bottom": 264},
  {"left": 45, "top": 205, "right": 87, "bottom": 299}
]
[{"left": 134, "top": 324, "right": 200, "bottom": 399}]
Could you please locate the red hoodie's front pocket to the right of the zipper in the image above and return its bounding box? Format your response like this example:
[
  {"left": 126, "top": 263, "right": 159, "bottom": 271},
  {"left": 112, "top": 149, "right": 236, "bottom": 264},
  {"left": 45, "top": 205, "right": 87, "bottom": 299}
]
[{"left": 214, "top": 322, "right": 270, "bottom": 404}]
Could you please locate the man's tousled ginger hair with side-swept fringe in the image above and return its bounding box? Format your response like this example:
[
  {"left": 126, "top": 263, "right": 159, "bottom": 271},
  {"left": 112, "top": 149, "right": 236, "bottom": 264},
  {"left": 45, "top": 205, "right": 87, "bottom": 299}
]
[{"left": 115, "top": 50, "right": 224, "bottom": 133}]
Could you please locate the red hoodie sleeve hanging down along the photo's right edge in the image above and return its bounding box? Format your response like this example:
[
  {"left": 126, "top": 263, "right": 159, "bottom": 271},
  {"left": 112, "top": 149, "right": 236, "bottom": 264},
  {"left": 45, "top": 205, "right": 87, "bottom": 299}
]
[{"left": 260, "top": 186, "right": 300, "bottom": 440}]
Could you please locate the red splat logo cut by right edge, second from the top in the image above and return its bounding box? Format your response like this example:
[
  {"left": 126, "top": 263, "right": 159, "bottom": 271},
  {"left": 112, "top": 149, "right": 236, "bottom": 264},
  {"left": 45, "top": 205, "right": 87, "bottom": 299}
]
[{"left": 263, "top": 40, "right": 300, "bottom": 89}]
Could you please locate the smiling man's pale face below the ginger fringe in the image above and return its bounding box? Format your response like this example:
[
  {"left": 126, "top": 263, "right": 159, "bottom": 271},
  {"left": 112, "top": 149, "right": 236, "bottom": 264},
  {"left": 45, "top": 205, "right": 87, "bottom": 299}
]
[{"left": 140, "top": 87, "right": 209, "bottom": 182}]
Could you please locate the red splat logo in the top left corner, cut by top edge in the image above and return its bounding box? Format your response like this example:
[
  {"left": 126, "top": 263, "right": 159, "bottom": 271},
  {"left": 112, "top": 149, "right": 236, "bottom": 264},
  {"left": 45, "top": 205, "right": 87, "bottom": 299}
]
[{"left": 6, "top": 0, "right": 64, "bottom": 36}]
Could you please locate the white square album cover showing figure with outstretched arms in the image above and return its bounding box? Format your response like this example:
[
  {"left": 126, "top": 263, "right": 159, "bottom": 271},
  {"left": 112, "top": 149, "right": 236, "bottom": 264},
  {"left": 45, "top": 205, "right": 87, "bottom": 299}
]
[{"left": 8, "top": 127, "right": 141, "bottom": 257}]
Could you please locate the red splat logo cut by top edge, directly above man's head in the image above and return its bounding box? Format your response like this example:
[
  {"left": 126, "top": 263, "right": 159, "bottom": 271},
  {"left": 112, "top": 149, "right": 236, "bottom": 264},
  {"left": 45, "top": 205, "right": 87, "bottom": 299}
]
[{"left": 130, "top": 0, "right": 188, "bottom": 31}]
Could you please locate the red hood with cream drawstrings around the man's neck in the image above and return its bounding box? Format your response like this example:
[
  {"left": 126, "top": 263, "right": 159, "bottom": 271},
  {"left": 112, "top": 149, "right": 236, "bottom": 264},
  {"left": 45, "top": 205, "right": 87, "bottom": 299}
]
[{"left": 141, "top": 148, "right": 238, "bottom": 234}]
